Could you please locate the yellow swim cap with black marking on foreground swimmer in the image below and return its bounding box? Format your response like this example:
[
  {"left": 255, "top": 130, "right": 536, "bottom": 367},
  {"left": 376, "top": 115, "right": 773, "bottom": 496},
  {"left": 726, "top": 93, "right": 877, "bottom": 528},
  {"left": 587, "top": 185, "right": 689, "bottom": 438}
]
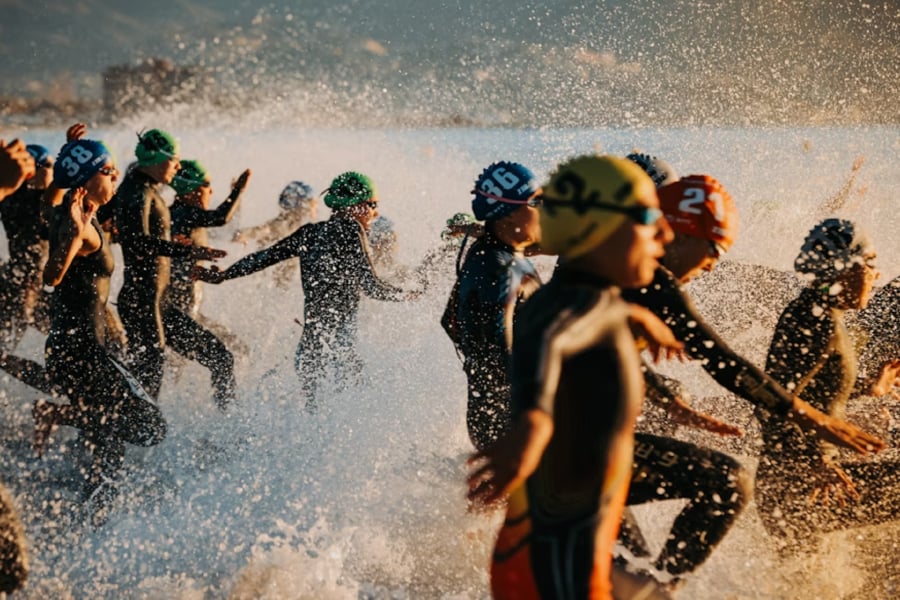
[{"left": 539, "top": 155, "right": 656, "bottom": 258}]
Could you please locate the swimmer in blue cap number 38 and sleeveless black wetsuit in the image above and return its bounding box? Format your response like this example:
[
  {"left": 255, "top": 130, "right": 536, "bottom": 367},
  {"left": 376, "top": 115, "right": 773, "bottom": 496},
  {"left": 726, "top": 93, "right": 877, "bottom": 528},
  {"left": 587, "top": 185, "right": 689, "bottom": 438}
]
[{"left": 34, "top": 139, "right": 166, "bottom": 525}]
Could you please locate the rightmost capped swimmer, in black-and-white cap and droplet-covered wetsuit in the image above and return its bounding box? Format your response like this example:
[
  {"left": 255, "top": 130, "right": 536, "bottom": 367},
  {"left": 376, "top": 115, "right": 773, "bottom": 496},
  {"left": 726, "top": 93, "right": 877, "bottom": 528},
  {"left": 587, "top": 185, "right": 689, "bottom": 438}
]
[{"left": 756, "top": 219, "right": 900, "bottom": 552}]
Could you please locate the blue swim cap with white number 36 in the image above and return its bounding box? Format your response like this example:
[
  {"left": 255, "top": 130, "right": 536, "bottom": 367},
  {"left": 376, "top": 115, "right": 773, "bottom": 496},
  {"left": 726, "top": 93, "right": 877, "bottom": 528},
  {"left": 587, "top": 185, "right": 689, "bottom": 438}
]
[{"left": 472, "top": 161, "right": 538, "bottom": 221}]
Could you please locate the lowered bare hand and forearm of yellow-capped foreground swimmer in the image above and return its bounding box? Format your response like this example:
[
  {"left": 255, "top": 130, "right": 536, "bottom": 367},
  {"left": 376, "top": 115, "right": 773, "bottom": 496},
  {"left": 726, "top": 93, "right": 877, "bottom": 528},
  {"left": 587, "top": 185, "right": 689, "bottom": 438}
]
[{"left": 467, "top": 409, "right": 553, "bottom": 508}]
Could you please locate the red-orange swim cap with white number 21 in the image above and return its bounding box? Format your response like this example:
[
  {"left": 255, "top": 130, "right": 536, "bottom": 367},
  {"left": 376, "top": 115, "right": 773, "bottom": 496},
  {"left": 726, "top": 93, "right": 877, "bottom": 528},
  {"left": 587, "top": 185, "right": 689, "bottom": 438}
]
[{"left": 658, "top": 175, "right": 738, "bottom": 254}]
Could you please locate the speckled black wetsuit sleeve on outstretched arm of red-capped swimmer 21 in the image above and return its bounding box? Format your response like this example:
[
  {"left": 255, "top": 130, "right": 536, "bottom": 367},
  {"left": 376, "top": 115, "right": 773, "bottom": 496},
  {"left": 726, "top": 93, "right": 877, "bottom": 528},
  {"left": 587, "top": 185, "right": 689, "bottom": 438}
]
[{"left": 626, "top": 270, "right": 793, "bottom": 415}]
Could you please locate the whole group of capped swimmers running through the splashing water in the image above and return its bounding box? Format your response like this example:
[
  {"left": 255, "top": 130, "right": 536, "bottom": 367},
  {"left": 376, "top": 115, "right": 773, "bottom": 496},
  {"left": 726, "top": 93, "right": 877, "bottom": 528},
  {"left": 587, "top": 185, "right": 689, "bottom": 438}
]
[{"left": 0, "top": 124, "right": 900, "bottom": 599}]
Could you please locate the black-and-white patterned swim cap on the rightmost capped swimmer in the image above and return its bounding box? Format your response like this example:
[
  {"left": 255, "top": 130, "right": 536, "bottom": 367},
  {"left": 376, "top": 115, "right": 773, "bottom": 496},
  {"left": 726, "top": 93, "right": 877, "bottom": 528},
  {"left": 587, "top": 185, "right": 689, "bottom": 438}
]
[{"left": 794, "top": 219, "right": 874, "bottom": 281}]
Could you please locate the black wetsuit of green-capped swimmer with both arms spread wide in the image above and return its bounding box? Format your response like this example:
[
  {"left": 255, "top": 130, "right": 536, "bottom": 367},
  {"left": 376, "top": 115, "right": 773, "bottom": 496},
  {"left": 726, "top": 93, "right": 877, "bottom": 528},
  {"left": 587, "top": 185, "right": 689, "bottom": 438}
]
[{"left": 224, "top": 216, "right": 407, "bottom": 410}]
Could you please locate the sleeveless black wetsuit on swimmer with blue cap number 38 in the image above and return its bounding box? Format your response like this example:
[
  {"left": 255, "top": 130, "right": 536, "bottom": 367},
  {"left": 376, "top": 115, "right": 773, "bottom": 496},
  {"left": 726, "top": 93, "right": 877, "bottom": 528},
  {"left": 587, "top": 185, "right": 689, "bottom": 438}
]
[{"left": 44, "top": 212, "right": 166, "bottom": 510}]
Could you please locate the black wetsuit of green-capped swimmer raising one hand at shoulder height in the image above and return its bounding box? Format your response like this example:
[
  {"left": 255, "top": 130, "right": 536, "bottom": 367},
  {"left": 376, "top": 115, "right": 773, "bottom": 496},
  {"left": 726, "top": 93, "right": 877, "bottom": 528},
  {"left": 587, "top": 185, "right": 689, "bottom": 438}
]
[{"left": 162, "top": 194, "right": 240, "bottom": 409}]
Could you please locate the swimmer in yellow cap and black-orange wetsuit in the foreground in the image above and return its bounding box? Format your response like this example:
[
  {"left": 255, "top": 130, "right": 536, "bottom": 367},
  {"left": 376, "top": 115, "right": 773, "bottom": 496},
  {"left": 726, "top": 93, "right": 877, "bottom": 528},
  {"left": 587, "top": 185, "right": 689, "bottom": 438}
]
[{"left": 469, "top": 156, "right": 672, "bottom": 600}]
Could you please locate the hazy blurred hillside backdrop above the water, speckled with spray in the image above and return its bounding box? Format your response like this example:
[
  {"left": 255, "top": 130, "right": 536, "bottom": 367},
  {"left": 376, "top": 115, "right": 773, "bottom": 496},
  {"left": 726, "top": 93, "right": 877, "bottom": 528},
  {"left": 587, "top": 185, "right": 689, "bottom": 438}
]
[{"left": 0, "top": 0, "right": 900, "bottom": 125}]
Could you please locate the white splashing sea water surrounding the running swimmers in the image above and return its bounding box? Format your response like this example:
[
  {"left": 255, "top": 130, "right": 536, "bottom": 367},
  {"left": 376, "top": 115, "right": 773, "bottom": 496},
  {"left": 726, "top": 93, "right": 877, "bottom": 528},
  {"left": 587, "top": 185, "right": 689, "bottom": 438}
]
[{"left": 0, "top": 124, "right": 900, "bottom": 600}]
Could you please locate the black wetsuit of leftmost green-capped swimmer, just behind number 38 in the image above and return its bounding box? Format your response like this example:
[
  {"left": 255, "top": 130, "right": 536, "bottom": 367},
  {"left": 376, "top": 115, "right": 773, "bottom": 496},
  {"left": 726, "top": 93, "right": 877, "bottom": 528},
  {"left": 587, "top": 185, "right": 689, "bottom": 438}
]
[{"left": 113, "top": 169, "right": 198, "bottom": 398}]
